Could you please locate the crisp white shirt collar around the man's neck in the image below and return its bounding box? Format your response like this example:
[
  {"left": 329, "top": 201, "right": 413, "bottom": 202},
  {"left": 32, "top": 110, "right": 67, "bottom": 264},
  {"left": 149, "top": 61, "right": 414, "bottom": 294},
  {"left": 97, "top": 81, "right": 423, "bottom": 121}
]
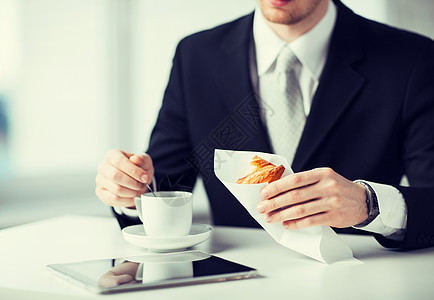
[{"left": 253, "top": 1, "right": 336, "bottom": 80}]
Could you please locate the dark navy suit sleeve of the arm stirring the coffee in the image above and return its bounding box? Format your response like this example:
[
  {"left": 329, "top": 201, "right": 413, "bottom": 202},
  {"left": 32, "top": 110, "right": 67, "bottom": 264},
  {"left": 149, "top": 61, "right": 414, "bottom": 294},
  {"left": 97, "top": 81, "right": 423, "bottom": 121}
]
[{"left": 113, "top": 41, "right": 197, "bottom": 228}]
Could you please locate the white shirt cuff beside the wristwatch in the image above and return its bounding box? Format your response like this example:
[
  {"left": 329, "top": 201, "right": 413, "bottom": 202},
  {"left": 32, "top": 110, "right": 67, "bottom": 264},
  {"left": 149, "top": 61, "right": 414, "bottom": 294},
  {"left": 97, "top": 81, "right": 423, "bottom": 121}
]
[{"left": 354, "top": 180, "right": 407, "bottom": 239}]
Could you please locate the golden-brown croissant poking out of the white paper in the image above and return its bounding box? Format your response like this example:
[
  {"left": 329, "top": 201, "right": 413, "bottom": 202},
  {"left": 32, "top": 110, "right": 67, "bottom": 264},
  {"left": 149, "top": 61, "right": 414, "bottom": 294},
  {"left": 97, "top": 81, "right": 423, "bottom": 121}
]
[{"left": 237, "top": 155, "right": 285, "bottom": 184}]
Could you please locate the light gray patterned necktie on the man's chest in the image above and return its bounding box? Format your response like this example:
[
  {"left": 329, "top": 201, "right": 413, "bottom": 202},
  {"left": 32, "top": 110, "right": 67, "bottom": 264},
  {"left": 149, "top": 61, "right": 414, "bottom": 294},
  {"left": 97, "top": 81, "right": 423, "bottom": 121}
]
[{"left": 266, "top": 46, "right": 306, "bottom": 164}]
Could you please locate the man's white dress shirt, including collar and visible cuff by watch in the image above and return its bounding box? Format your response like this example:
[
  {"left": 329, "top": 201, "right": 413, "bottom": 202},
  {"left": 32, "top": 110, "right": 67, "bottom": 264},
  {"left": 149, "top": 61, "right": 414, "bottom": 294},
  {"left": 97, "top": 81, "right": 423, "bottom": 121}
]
[{"left": 250, "top": 1, "right": 407, "bottom": 240}]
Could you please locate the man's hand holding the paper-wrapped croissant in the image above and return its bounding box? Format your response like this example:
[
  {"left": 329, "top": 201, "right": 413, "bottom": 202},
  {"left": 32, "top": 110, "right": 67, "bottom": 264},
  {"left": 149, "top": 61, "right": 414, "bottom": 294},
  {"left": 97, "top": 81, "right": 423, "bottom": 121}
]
[{"left": 257, "top": 168, "right": 368, "bottom": 229}]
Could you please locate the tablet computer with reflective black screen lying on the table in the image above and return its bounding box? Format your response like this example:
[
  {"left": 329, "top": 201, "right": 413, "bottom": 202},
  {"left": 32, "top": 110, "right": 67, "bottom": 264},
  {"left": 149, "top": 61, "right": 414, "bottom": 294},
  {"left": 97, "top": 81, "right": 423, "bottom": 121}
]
[{"left": 47, "top": 250, "right": 257, "bottom": 294}]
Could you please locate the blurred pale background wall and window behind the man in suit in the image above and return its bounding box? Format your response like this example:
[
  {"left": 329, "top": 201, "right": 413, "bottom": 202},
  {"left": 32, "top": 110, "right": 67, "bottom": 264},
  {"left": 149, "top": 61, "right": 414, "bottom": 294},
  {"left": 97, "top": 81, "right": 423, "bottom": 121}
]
[{"left": 0, "top": 0, "right": 434, "bottom": 229}]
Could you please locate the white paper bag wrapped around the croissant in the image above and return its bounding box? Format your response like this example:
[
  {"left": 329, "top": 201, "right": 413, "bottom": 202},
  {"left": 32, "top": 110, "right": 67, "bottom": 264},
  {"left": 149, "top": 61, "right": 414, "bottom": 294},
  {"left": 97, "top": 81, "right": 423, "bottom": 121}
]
[{"left": 214, "top": 149, "right": 357, "bottom": 263}]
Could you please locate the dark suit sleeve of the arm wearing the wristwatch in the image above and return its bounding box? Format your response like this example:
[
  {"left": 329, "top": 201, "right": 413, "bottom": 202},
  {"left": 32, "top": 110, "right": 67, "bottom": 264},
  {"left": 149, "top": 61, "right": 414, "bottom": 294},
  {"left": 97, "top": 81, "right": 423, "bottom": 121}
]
[{"left": 375, "top": 41, "right": 434, "bottom": 249}]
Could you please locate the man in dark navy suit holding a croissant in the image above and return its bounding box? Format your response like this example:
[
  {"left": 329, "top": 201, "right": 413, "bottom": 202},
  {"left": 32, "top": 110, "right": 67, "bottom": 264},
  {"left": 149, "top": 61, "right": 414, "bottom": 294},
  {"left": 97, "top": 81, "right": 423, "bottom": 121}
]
[{"left": 96, "top": 0, "right": 434, "bottom": 249}]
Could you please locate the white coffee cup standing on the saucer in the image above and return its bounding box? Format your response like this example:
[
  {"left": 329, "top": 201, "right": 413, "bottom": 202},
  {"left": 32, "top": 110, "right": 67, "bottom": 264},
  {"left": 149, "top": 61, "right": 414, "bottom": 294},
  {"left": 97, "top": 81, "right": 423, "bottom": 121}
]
[{"left": 134, "top": 191, "right": 193, "bottom": 237}]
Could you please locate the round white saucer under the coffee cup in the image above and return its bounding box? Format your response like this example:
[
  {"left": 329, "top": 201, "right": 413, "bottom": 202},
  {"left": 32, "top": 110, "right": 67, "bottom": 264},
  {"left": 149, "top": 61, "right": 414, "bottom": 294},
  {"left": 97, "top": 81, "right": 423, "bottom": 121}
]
[{"left": 122, "top": 224, "right": 212, "bottom": 252}]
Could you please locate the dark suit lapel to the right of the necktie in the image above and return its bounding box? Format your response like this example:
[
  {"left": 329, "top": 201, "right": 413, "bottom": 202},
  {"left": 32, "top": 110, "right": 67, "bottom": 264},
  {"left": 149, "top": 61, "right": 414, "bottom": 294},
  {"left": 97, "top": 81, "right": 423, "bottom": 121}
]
[{"left": 292, "top": 3, "right": 365, "bottom": 171}]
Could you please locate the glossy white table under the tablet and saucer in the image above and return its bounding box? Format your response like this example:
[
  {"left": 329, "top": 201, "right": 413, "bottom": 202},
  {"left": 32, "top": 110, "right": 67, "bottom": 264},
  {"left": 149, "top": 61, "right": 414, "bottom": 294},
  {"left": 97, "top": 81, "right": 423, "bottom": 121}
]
[{"left": 0, "top": 216, "right": 434, "bottom": 300}]
